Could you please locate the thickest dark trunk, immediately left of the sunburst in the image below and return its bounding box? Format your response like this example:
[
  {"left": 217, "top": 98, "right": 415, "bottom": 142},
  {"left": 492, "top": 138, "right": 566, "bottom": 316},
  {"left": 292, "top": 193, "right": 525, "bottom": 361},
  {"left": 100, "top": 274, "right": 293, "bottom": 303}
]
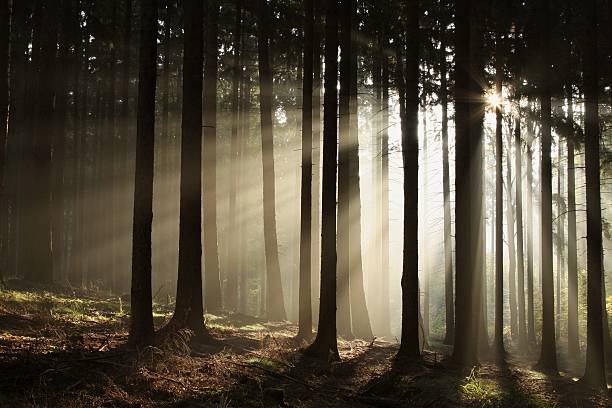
[{"left": 453, "top": 0, "right": 486, "bottom": 366}]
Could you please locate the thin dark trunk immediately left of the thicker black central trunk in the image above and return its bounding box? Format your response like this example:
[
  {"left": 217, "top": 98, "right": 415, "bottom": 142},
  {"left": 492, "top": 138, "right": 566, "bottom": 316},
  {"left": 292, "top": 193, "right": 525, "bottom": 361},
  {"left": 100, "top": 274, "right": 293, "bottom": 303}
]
[{"left": 298, "top": 0, "right": 318, "bottom": 339}]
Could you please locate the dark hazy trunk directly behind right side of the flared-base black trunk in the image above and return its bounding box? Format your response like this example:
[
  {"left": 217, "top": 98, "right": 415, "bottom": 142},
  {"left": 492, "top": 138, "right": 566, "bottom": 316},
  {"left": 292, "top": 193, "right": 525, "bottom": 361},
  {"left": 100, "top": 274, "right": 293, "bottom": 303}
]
[{"left": 202, "top": 0, "right": 222, "bottom": 312}]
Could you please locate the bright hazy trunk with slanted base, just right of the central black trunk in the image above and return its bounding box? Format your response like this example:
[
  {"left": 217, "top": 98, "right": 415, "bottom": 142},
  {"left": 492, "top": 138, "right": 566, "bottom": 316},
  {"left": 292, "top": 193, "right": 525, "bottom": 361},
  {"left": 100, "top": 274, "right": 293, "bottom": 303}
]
[{"left": 348, "top": 18, "right": 372, "bottom": 339}]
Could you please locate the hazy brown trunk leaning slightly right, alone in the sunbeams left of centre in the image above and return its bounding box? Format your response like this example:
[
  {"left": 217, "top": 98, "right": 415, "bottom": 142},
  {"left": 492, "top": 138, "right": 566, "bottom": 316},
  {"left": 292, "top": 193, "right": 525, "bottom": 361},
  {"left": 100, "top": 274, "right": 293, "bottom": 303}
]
[{"left": 257, "top": 0, "right": 288, "bottom": 321}]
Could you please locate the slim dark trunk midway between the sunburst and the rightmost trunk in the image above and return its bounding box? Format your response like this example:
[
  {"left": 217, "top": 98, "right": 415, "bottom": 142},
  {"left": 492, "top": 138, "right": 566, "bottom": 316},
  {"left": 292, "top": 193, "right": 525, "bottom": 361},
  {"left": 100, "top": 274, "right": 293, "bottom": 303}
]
[{"left": 538, "top": 0, "right": 557, "bottom": 370}]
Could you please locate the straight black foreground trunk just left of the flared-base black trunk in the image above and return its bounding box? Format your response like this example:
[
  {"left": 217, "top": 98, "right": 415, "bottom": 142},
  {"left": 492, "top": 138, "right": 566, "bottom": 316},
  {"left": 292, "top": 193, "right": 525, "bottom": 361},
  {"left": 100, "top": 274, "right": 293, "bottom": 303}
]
[{"left": 130, "top": 0, "right": 157, "bottom": 344}]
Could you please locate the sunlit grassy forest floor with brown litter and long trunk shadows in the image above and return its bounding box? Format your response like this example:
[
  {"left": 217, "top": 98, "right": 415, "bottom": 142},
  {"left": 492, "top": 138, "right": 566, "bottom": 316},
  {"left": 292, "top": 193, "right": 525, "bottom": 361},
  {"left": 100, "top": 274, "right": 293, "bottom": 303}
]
[{"left": 0, "top": 282, "right": 612, "bottom": 408}]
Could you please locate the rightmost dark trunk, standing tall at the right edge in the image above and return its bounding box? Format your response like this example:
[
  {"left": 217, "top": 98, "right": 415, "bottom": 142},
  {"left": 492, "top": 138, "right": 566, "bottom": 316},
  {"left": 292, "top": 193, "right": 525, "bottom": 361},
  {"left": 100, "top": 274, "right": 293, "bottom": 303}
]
[{"left": 582, "top": 0, "right": 608, "bottom": 389}]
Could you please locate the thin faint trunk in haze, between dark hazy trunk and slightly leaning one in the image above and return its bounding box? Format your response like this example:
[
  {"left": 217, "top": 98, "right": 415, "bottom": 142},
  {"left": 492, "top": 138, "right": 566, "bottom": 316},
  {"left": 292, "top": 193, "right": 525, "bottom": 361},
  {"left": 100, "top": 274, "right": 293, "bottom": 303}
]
[{"left": 225, "top": 0, "right": 242, "bottom": 310}]
